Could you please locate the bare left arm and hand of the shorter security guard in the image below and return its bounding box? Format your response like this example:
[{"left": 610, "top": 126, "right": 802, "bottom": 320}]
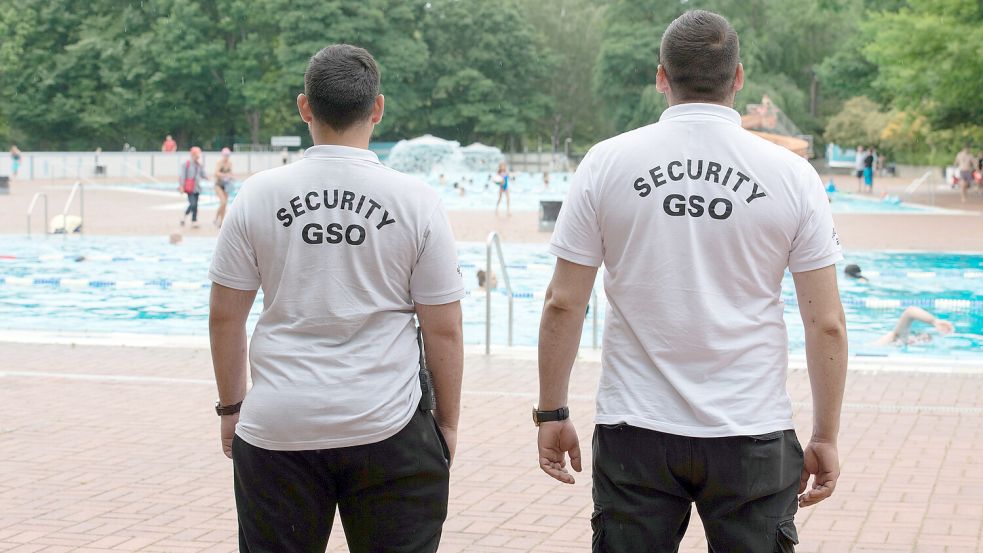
[{"left": 208, "top": 283, "right": 256, "bottom": 458}]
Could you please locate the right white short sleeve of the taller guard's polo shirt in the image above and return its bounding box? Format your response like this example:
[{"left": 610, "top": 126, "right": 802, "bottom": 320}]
[{"left": 788, "top": 167, "right": 843, "bottom": 273}]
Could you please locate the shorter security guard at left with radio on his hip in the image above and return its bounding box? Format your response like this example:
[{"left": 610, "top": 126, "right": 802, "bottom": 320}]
[{"left": 209, "top": 44, "right": 465, "bottom": 553}]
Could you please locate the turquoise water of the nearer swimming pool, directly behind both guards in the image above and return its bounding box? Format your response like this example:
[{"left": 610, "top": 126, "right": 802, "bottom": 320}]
[{"left": 0, "top": 235, "right": 983, "bottom": 359}]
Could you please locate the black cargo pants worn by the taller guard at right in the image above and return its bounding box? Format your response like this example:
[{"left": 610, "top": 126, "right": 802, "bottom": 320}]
[{"left": 591, "top": 424, "right": 802, "bottom": 553}]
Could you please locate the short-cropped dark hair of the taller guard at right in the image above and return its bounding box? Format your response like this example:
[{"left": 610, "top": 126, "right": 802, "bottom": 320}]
[{"left": 659, "top": 10, "right": 740, "bottom": 102}]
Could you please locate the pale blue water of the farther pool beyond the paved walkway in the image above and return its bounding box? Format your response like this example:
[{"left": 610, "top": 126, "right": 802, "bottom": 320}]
[{"left": 104, "top": 172, "right": 944, "bottom": 214}]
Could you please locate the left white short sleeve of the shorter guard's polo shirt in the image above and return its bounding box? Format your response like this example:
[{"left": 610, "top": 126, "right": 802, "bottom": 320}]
[{"left": 208, "top": 193, "right": 261, "bottom": 290}]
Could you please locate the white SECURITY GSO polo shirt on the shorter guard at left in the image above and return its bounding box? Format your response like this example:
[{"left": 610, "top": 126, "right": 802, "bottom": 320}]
[{"left": 209, "top": 146, "right": 465, "bottom": 450}]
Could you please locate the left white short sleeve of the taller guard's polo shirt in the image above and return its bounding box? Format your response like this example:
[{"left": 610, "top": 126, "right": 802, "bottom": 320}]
[{"left": 550, "top": 149, "right": 604, "bottom": 267}]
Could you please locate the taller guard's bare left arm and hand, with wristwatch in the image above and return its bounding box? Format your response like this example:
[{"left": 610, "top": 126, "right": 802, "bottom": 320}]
[{"left": 538, "top": 259, "right": 597, "bottom": 484}]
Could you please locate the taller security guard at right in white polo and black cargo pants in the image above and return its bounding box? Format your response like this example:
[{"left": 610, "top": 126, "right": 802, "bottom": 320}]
[{"left": 533, "top": 10, "right": 847, "bottom": 553}]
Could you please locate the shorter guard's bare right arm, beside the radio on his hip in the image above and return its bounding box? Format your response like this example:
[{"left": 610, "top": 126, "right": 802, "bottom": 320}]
[{"left": 416, "top": 301, "right": 464, "bottom": 461}]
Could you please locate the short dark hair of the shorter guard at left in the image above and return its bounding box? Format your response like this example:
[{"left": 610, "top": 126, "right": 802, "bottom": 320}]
[{"left": 304, "top": 44, "right": 379, "bottom": 131}]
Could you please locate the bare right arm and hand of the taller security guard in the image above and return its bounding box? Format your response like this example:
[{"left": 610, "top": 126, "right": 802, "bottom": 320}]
[{"left": 792, "top": 265, "right": 847, "bottom": 507}]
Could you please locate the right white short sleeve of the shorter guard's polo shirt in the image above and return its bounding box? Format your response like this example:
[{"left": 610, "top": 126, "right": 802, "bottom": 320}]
[{"left": 410, "top": 204, "right": 466, "bottom": 305}]
